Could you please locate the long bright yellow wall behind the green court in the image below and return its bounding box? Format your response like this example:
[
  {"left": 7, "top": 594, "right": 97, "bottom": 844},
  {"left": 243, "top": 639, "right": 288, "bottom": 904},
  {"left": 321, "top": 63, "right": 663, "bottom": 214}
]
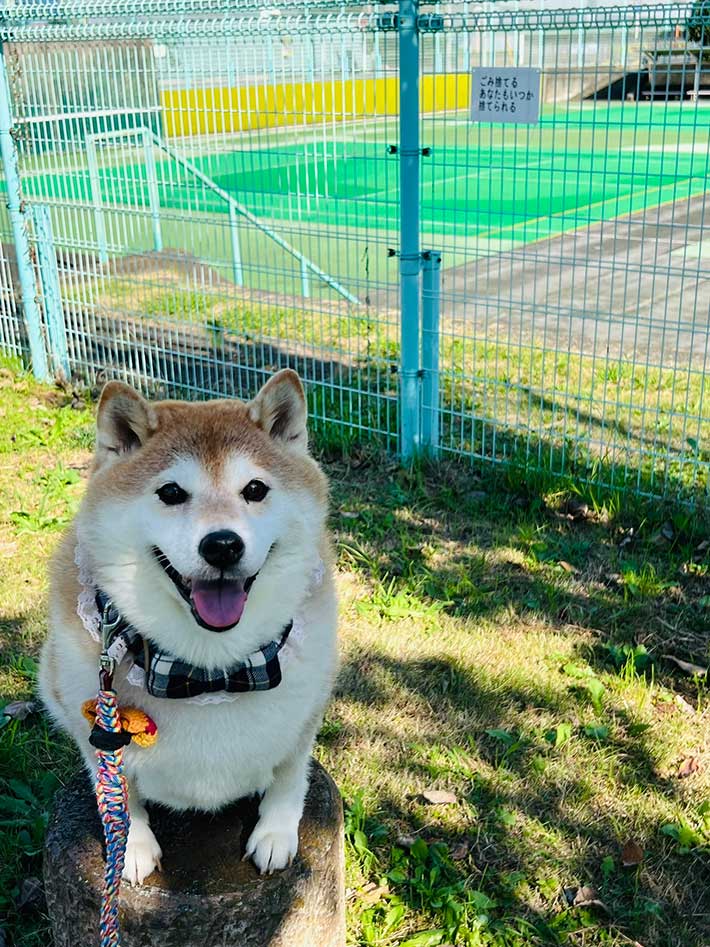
[{"left": 161, "top": 73, "right": 470, "bottom": 138}]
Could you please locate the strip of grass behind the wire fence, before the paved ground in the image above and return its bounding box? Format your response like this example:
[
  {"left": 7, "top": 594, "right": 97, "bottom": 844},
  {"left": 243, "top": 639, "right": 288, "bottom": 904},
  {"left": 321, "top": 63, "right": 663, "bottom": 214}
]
[{"left": 85, "top": 265, "right": 710, "bottom": 506}]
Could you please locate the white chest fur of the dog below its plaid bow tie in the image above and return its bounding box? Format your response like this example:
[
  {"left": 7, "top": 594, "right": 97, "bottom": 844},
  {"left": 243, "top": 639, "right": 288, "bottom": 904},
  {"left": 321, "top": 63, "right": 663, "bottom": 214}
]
[{"left": 44, "top": 577, "right": 337, "bottom": 810}]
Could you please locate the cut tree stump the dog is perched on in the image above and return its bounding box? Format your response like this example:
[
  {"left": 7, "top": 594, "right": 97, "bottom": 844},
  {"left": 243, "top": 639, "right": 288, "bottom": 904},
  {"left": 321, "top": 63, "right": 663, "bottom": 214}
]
[{"left": 44, "top": 762, "right": 345, "bottom": 947}]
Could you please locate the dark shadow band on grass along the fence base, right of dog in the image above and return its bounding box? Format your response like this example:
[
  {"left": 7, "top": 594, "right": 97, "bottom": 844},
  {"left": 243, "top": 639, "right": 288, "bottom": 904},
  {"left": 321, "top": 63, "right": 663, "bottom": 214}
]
[{"left": 331, "top": 457, "right": 710, "bottom": 668}]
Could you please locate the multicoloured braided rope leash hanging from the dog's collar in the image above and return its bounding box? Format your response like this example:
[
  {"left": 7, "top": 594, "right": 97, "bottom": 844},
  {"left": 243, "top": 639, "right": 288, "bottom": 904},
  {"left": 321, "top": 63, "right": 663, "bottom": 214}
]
[{"left": 89, "top": 652, "right": 131, "bottom": 947}]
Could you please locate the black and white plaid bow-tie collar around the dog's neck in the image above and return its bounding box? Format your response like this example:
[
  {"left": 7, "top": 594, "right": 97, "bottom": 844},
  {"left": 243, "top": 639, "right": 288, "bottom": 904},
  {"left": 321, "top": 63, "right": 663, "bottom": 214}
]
[{"left": 96, "top": 591, "right": 293, "bottom": 698}]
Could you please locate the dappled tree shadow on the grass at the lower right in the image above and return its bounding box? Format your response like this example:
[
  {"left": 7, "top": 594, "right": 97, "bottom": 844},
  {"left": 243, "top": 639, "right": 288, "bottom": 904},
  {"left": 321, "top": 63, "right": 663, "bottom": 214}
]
[{"left": 330, "top": 651, "right": 710, "bottom": 947}]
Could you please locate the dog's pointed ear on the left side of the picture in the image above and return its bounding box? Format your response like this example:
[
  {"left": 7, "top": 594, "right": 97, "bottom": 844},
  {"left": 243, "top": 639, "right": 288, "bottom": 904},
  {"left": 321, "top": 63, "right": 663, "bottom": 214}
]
[{"left": 96, "top": 381, "right": 158, "bottom": 466}]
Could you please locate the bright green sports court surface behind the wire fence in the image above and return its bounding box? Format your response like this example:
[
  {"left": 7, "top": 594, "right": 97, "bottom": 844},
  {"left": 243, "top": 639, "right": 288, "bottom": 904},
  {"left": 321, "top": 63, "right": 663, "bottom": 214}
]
[{"left": 13, "top": 103, "right": 710, "bottom": 245}]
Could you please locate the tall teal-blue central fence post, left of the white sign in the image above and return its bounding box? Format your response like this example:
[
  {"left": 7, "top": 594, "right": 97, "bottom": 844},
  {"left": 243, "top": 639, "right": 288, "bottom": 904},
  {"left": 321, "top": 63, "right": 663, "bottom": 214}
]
[{"left": 399, "top": 0, "right": 421, "bottom": 460}]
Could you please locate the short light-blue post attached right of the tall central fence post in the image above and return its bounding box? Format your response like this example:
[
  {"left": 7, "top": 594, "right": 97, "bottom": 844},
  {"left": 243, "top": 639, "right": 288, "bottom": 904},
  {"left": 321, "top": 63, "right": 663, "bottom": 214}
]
[{"left": 421, "top": 250, "right": 441, "bottom": 454}]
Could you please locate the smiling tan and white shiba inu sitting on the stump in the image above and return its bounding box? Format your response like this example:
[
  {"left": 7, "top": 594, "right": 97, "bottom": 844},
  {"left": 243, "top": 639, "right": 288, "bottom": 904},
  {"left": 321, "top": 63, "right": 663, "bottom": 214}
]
[{"left": 40, "top": 369, "right": 336, "bottom": 884}]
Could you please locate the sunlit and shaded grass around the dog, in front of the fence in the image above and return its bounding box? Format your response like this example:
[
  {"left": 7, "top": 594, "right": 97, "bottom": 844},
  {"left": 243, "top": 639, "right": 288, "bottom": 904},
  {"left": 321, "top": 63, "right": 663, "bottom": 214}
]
[{"left": 0, "top": 366, "right": 710, "bottom": 947}]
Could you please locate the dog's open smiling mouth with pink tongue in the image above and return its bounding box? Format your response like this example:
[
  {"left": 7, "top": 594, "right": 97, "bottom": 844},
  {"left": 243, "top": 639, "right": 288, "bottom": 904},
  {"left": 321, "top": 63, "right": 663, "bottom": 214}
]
[{"left": 153, "top": 546, "right": 256, "bottom": 631}]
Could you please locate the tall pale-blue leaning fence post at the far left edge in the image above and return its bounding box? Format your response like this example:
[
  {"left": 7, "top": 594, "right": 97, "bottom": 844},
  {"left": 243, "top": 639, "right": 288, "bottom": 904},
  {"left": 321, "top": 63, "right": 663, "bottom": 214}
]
[{"left": 0, "top": 43, "right": 49, "bottom": 381}]
